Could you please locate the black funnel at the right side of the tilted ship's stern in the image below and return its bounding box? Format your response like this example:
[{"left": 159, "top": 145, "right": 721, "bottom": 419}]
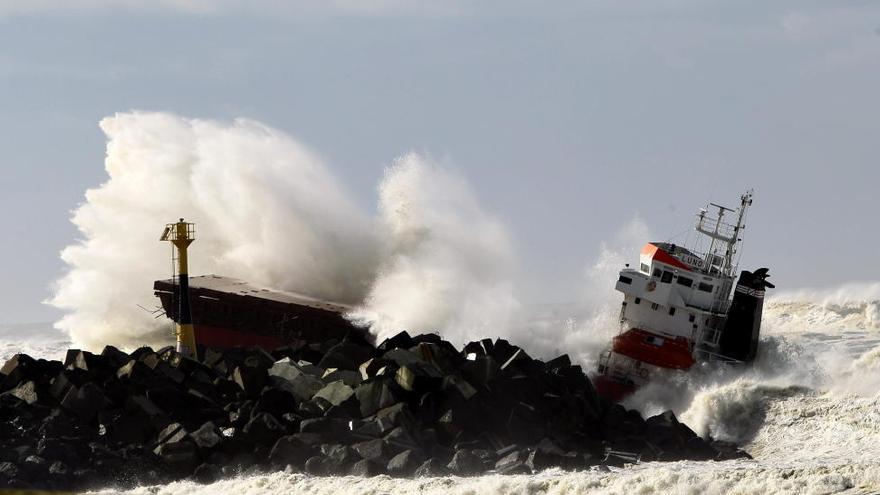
[{"left": 718, "top": 268, "right": 775, "bottom": 362}]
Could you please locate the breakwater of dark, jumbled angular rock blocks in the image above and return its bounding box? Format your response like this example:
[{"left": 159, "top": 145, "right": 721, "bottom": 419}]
[{"left": 0, "top": 333, "right": 747, "bottom": 489}]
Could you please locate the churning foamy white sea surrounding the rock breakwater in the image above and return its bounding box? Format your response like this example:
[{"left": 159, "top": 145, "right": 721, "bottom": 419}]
[{"left": 0, "top": 287, "right": 880, "bottom": 495}]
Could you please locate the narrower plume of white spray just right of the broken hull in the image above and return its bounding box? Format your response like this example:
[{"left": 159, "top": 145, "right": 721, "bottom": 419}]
[{"left": 353, "top": 154, "right": 519, "bottom": 344}]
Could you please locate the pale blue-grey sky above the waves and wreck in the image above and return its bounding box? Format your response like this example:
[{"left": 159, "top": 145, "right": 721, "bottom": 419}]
[{"left": 0, "top": 0, "right": 880, "bottom": 323}]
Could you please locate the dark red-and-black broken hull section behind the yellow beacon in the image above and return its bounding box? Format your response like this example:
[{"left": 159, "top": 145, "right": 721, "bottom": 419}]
[{"left": 153, "top": 276, "right": 369, "bottom": 351}]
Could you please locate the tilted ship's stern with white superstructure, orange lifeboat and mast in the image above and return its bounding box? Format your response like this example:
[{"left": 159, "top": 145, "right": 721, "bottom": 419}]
[{"left": 594, "top": 191, "right": 774, "bottom": 401}]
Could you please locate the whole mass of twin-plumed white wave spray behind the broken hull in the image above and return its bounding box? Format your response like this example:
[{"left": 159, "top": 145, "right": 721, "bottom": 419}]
[{"left": 49, "top": 112, "right": 517, "bottom": 348}]
